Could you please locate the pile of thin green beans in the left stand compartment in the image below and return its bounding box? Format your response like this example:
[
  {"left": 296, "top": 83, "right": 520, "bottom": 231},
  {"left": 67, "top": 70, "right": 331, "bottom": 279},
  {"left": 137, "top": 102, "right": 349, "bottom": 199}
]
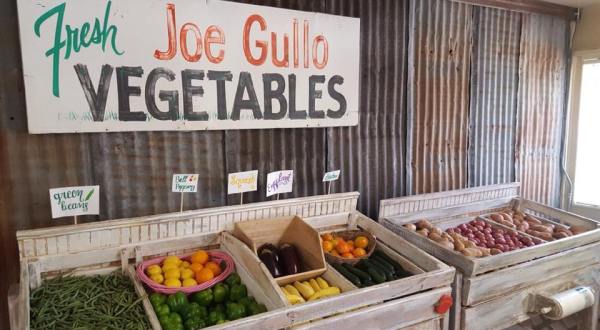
[{"left": 30, "top": 272, "right": 151, "bottom": 330}]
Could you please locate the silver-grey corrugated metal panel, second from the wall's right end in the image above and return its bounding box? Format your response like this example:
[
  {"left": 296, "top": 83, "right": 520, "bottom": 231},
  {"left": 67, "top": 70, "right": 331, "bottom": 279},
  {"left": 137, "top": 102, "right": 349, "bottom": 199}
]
[{"left": 469, "top": 7, "right": 521, "bottom": 187}]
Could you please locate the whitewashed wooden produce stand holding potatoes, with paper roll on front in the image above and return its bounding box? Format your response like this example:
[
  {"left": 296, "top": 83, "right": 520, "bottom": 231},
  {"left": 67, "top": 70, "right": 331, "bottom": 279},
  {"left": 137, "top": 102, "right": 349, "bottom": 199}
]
[{"left": 379, "top": 183, "right": 600, "bottom": 329}]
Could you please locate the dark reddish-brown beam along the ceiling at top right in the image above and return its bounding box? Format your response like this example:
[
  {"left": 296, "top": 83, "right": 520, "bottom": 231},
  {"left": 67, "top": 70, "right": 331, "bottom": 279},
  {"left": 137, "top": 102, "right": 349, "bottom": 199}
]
[{"left": 451, "top": 0, "right": 579, "bottom": 20}]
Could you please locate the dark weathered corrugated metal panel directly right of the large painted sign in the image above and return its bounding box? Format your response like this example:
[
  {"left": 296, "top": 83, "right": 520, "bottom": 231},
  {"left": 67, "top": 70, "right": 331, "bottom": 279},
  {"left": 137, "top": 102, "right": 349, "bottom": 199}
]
[{"left": 327, "top": 0, "right": 408, "bottom": 218}]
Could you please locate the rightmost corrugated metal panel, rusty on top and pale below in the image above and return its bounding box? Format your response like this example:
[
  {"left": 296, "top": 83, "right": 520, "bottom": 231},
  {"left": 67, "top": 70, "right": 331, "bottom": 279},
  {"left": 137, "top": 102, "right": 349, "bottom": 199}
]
[{"left": 516, "top": 14, "right": 569, "bottom": 206}]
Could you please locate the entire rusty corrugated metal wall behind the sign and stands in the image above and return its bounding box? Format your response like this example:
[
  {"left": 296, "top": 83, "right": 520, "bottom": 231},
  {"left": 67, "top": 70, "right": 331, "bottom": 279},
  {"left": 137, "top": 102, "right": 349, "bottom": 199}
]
[{"left": 0, "top": 0, "right": 568, "bottom": 328}]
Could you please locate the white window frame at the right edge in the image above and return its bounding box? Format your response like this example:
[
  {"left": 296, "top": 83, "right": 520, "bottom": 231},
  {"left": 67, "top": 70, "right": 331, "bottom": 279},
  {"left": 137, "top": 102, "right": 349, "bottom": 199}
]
[{"left": 562, "top": 49, "right": 600, "bottom": 219}]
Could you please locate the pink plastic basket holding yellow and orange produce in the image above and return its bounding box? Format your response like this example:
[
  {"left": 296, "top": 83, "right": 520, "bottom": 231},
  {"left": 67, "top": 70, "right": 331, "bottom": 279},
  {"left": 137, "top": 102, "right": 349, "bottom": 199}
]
[{"left": 136, "top": 250, "right": 235, "bottom": 294}]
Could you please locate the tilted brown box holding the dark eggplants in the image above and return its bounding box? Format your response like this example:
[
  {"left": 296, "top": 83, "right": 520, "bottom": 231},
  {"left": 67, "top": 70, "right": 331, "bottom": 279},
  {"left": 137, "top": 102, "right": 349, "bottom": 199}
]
[{"left": 233, "top": 216, "right": 327, "bottom": 285}]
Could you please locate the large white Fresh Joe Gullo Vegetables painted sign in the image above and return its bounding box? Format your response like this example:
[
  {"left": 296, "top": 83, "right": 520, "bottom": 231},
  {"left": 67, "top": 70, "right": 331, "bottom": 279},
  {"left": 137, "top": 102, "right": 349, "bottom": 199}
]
[{"left": 17, "top": 0, "right": 360, "bottom": 133}]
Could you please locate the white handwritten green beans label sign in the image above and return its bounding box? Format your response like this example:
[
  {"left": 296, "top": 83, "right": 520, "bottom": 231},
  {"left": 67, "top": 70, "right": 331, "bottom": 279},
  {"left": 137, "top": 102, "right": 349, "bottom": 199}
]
[{"left": 50, "top": 186, "right": 100, "bottom": 218}]
